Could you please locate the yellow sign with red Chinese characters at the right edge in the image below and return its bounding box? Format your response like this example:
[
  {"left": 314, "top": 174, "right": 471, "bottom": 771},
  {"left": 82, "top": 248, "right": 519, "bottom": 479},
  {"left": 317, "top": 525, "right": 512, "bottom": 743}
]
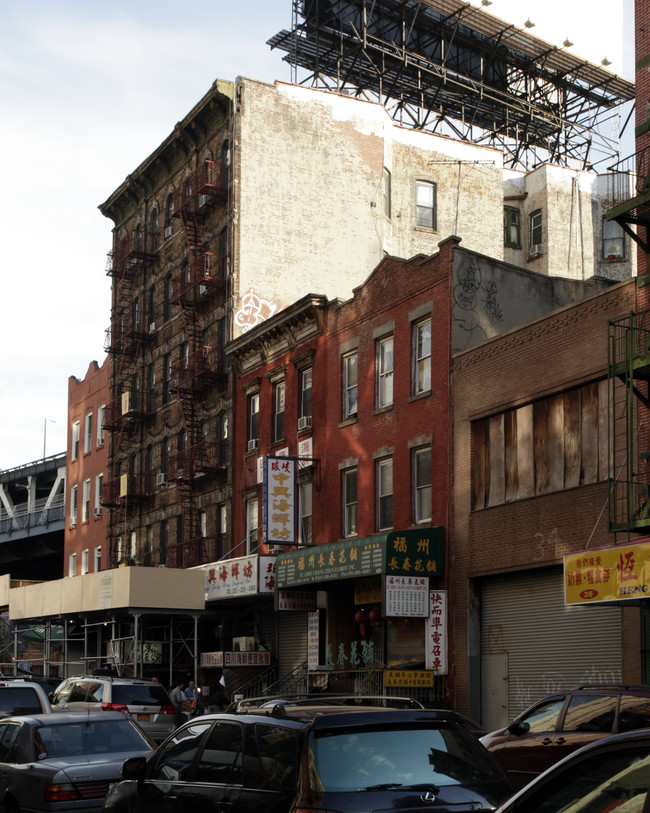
[{"left": 564, "top": 542, "right": 650, "bottom": 604}]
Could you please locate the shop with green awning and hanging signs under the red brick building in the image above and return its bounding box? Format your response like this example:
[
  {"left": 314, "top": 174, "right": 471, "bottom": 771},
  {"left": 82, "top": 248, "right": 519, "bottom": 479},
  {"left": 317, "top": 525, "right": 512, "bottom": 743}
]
[{"left": 276, "top": 527, "right": 448, "bottom": 702}]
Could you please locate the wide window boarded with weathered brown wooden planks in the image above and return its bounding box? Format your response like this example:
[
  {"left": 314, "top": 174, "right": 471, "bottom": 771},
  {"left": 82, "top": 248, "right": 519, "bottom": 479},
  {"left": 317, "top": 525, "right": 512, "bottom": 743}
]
[{"left": 472, "top": 382, "right": 607, "bottom": 509}]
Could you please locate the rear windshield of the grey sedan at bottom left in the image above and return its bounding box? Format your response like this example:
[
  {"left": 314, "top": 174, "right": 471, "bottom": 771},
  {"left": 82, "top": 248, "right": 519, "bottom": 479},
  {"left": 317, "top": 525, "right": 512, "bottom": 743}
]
[{"left": 34, "top": 720, "right": 149, "bottom": 760}]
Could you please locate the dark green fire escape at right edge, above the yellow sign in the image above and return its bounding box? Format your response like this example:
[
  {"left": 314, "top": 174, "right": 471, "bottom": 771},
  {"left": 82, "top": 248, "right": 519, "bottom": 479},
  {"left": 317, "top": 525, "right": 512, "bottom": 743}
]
[{"left": 608, "top": 313, "right": 650, "bottom": 535}]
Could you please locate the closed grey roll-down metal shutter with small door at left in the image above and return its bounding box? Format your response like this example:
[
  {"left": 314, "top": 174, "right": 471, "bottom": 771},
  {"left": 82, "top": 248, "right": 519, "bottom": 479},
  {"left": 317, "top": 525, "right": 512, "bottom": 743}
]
[{"left": 481, "top": 568, "right": 623, "bottom": 729}]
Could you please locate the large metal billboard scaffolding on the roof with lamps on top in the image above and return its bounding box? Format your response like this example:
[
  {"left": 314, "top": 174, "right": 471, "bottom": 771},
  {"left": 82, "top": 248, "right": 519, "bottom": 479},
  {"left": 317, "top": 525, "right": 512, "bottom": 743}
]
[{"left": 268, "top": 0, "right": 634, "bottom": 169}]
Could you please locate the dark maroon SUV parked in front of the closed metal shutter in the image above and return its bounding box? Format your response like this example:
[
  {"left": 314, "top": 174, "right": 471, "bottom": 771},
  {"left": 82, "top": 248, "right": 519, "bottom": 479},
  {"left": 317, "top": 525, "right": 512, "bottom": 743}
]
[{"left": 481, "top": 685, "right": 650, "bottom": 790}]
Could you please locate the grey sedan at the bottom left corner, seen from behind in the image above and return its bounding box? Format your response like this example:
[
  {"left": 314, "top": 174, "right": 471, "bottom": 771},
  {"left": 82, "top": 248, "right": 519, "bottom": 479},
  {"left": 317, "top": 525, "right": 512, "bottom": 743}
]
[{"left": 0, "top": 712, "right": 154, "bottom": 813}]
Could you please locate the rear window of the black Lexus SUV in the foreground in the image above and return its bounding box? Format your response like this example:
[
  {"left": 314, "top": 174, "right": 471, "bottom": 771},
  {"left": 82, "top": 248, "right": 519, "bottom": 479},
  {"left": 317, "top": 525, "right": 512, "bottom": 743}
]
[{"left": 310, "top": 724, "right": 503, "bottom": 791}]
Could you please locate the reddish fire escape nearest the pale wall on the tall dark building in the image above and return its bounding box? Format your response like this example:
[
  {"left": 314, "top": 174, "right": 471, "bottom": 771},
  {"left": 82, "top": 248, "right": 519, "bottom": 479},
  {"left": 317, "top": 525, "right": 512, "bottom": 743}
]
[{"left": 168, "top": 161, "right": 228, "bottom": 567}]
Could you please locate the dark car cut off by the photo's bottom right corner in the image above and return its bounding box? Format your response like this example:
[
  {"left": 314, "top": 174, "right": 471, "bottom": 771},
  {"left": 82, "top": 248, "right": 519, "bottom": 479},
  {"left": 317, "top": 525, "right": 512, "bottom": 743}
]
[{"left": 498, "top": 729, "right": 650, "bottom": 813}]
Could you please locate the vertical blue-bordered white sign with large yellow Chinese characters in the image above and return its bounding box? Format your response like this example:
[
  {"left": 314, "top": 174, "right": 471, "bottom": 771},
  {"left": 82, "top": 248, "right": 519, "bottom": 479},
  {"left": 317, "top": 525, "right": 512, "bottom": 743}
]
[{"left": 263, "top": 457, "right": 297, "bottom": 545}]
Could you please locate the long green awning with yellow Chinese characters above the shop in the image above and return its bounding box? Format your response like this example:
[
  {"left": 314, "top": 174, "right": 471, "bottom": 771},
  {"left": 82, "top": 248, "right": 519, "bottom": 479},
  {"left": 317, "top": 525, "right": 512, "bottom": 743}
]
[{"left": 275, "top": 526, "right": 444, "bottom": 589}]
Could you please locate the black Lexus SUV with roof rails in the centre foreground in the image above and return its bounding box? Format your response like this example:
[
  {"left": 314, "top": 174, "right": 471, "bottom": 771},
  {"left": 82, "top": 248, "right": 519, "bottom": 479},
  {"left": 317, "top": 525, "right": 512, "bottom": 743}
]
[{"left": 104, "top": 701, "right": 511, "bottom": 813}]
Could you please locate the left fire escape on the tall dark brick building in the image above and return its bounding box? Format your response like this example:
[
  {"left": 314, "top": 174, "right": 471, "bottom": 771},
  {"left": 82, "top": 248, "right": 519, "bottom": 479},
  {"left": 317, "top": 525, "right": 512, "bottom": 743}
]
[{"left": 101, "top": 227, "right": 158, "bottom": 565}]
